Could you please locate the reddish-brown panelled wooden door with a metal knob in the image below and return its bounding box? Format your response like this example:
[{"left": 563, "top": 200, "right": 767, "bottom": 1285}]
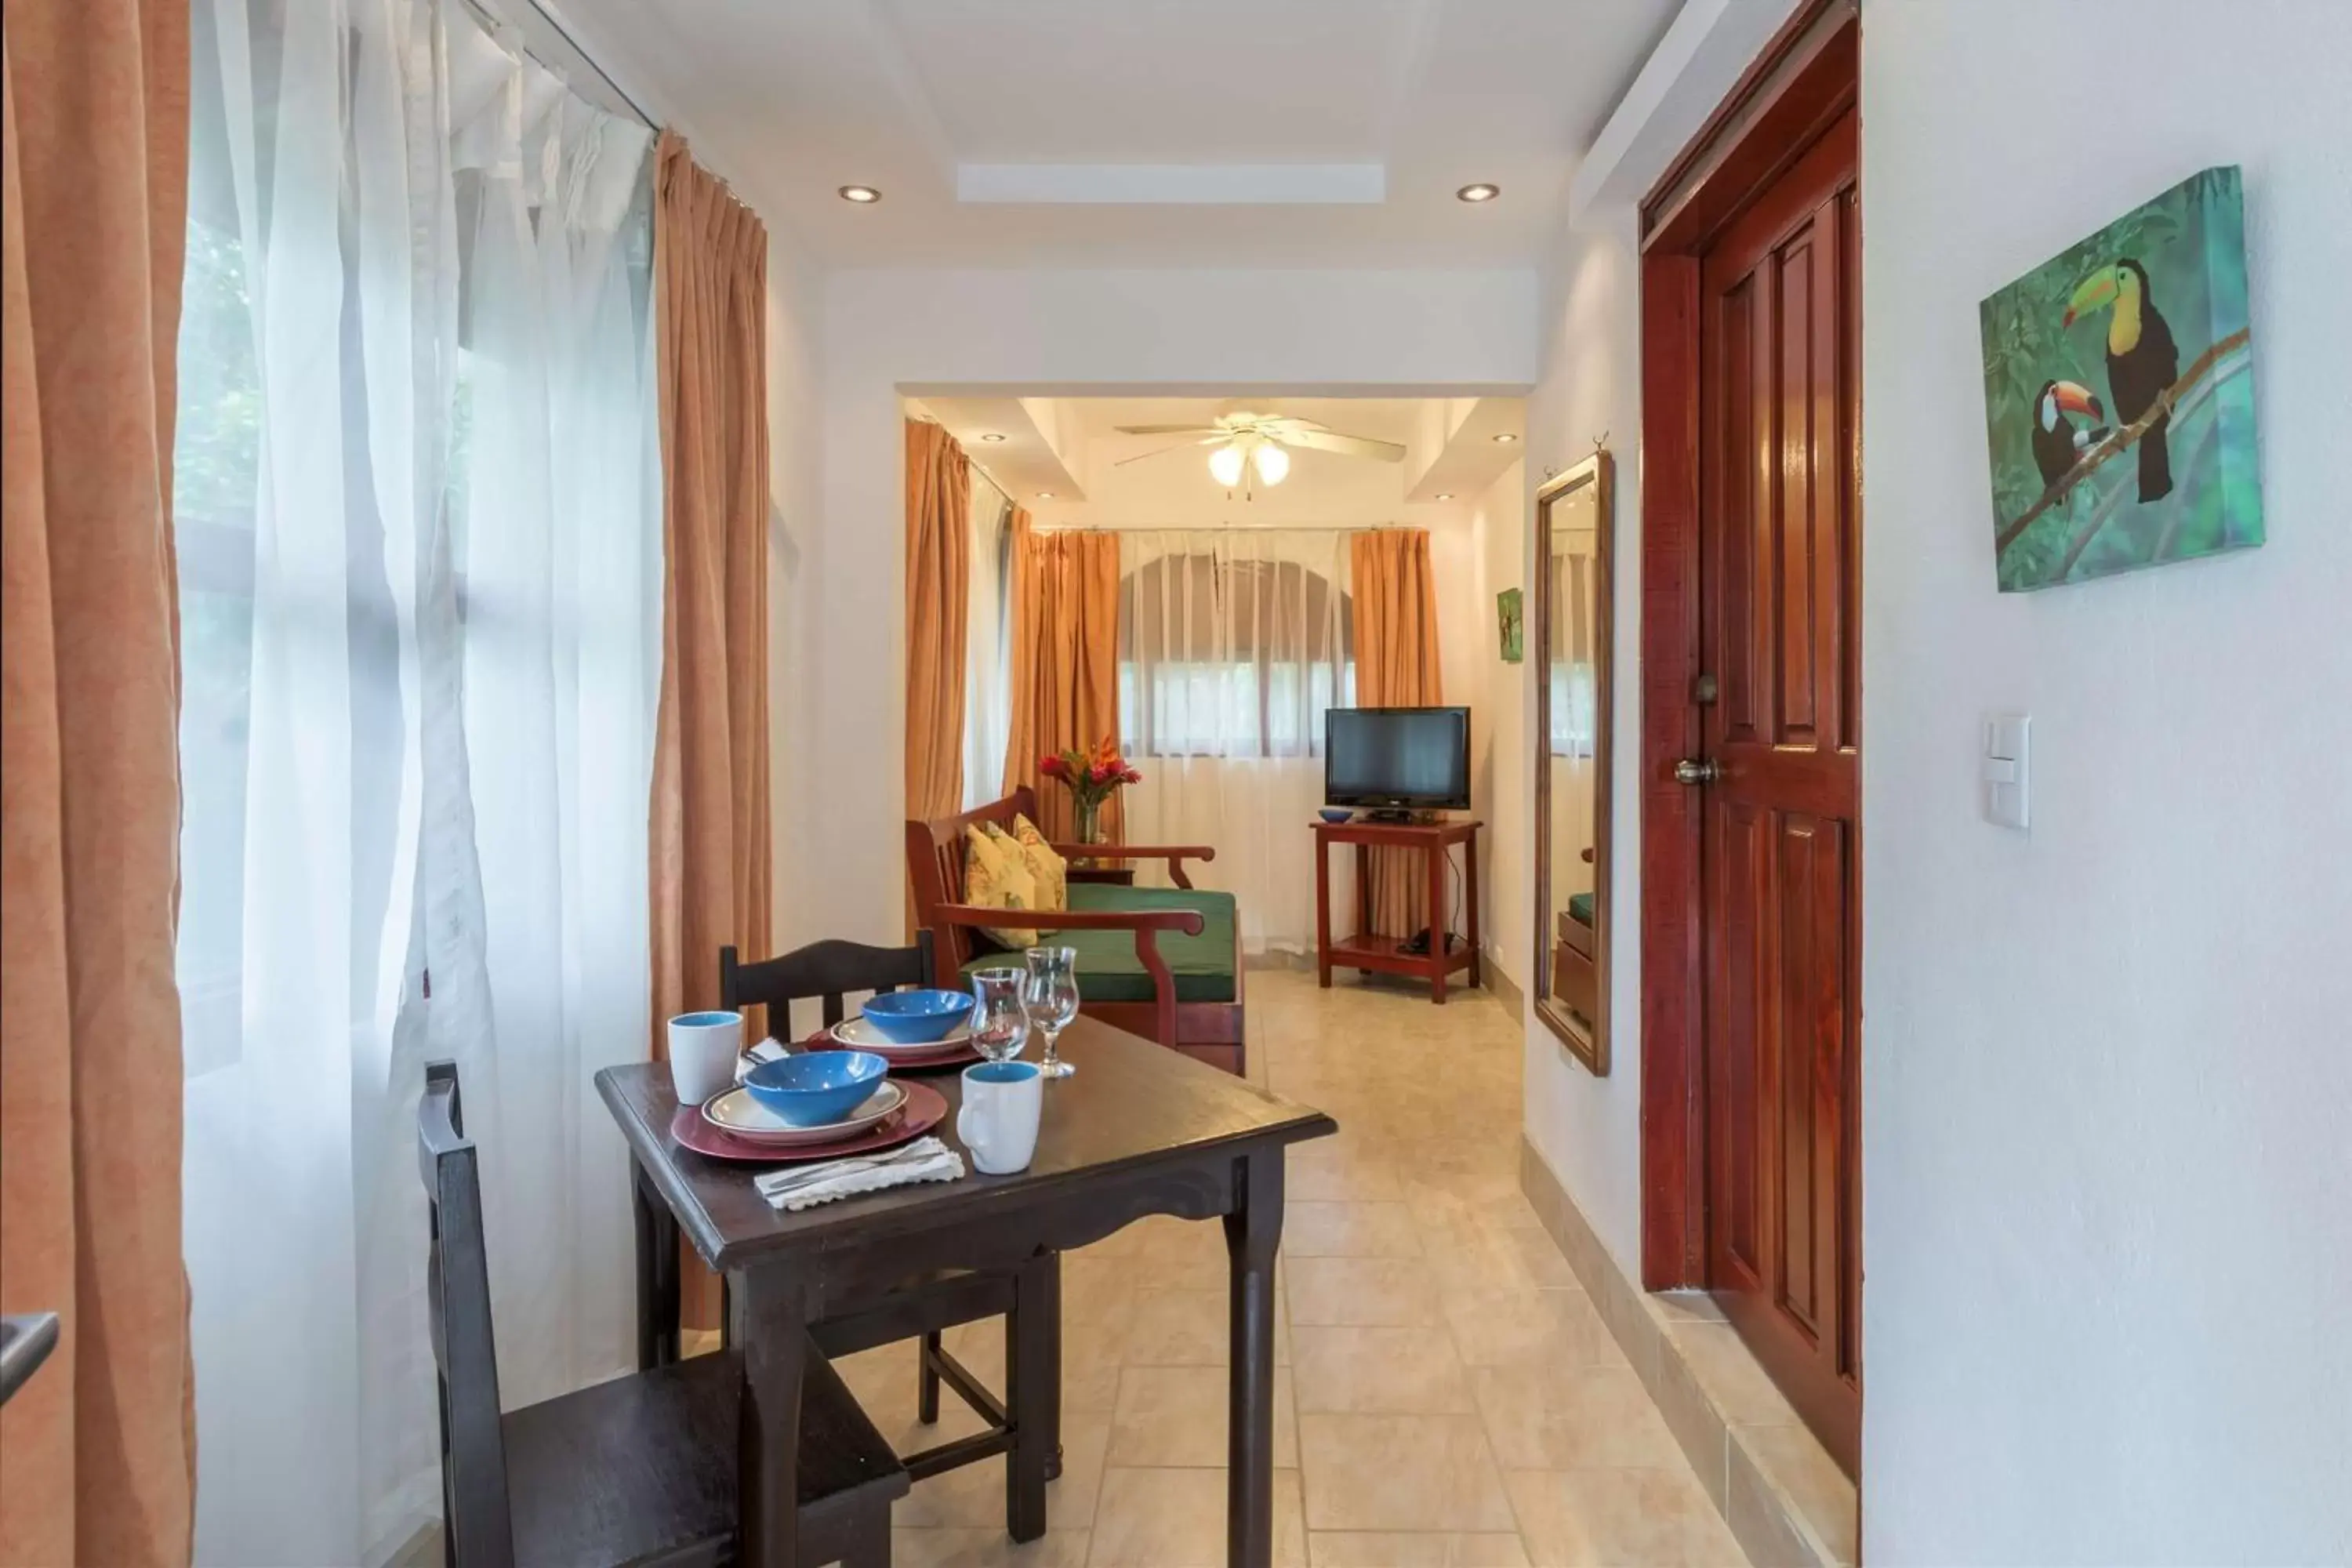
[{"left": 1698, "top": 111, "right": 1860, "bottom": 1469}]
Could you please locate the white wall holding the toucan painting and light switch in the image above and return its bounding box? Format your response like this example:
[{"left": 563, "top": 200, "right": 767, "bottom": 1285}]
[{"left": 1863, "top": 0, "right": 2352, "bottom": 1563}]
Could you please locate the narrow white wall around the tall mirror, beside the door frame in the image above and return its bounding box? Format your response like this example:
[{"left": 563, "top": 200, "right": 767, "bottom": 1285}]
[{"left": 1510, "top": 207, "right": 1642, "bottom": 1279}]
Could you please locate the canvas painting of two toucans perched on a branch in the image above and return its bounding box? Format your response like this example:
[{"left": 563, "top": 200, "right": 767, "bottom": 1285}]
[{"left": 1978, "top": 167, "right": 2263, "bottom": 593}]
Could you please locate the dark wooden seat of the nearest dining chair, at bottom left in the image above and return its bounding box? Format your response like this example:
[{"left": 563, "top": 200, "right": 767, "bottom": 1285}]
[{"left": 501, "top": 1354, "right": 908, "bottom": 1568}]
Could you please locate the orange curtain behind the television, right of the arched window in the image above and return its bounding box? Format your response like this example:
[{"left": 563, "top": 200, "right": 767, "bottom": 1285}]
[{"left": 1350, "top": 529, "right": 1444, "bottom": 935}]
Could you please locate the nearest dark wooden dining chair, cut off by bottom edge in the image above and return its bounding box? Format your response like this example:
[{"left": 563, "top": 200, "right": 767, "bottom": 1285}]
[{"left": 416, "top": 1062, "right": 908, "bottom": 1568}]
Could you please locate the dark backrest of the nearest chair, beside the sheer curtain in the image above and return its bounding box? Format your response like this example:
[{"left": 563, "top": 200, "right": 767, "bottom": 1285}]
[{"left": 416, "top": 1062, "right": 515, "bottom": 1568}]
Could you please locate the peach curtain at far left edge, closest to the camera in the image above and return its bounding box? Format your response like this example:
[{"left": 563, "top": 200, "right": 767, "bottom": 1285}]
[{"left": 0, "top": 0, "right": 195, "bottom": 1568}]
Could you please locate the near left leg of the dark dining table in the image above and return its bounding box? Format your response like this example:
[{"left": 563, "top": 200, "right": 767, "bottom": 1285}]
[{"left": 729, "top": 1267, "right": 809, "bottom": 1568}]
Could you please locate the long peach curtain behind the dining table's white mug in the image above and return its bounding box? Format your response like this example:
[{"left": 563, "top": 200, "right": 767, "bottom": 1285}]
[{"left": 652, "top": 132, "right": 774, "bottom": 1326}]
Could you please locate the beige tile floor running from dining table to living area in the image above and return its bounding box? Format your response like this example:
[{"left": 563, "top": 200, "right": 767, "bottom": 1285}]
[{"left": 842, "top": 971, "right": 1745, "bottom": 1568}]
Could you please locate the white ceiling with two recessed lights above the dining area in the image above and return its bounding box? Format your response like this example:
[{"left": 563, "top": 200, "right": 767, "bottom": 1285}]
[{"left": 548, "top": 0, "right": 1677, "bottom": 268}]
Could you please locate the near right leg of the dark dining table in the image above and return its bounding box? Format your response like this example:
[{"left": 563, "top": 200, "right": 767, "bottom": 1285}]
[{"left": 1225, "top": 1147, "right": 1282, "bottom": 1568}]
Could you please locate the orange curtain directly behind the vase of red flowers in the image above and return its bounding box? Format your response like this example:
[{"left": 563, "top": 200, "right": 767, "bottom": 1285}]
[{"left": 1004, "top": 521, "right": 1124, "bottom": 844}]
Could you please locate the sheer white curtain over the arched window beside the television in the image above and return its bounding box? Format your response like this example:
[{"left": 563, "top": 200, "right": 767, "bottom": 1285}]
[{"left": 1120, "top": 529, "right": 1355, "bottom": 952}]
